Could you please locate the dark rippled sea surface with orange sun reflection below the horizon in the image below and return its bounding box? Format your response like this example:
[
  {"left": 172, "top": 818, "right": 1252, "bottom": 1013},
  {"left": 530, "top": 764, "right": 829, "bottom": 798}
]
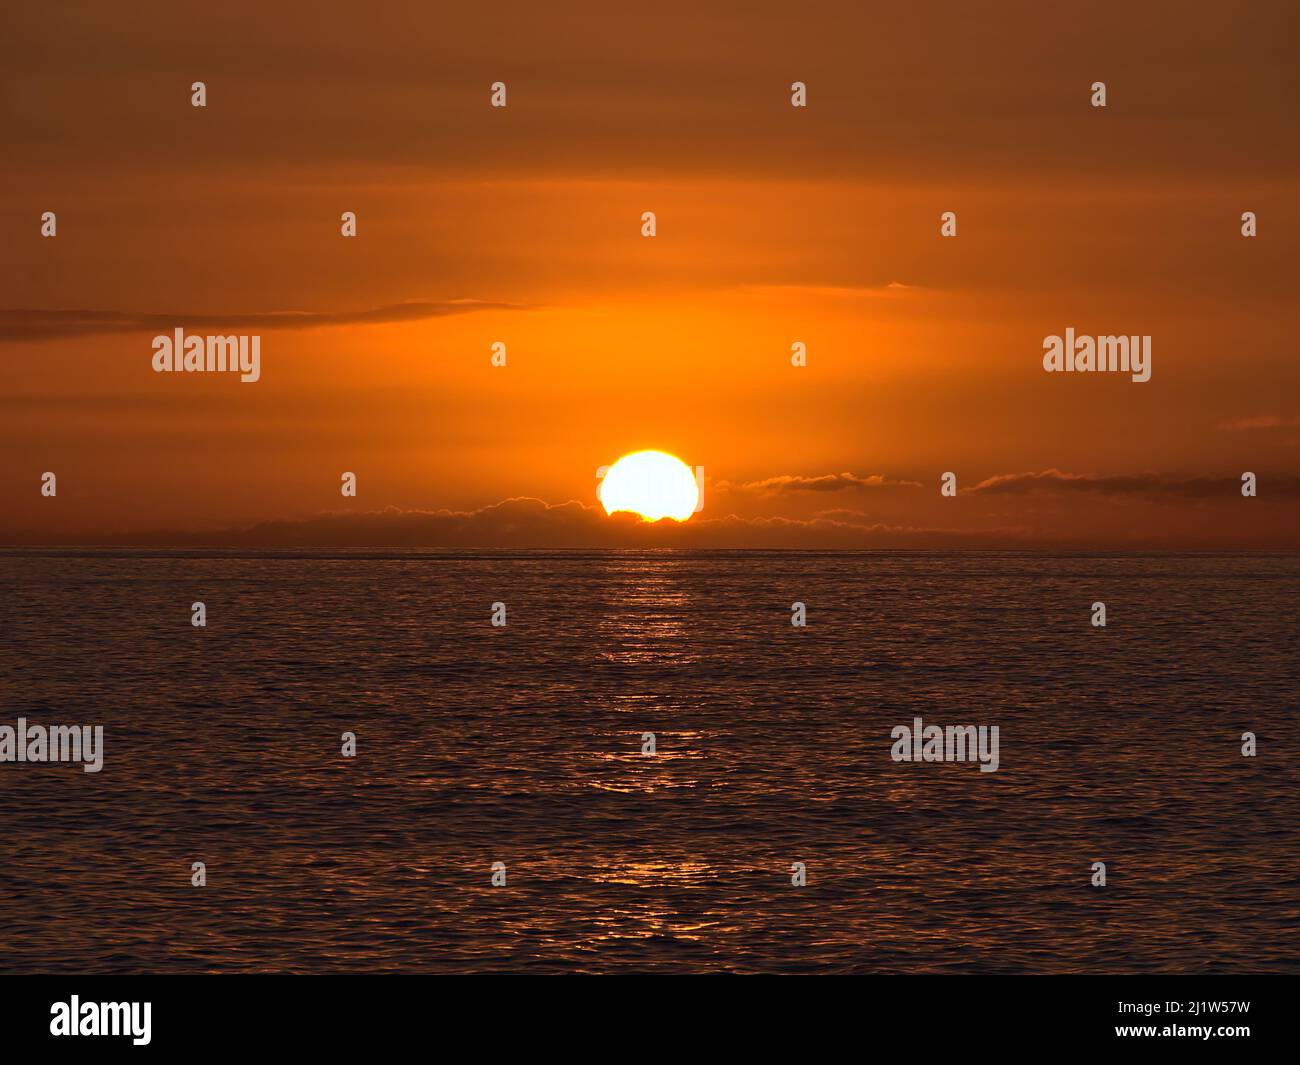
[{"left": 0, "top": 551, "right": 1300, "bottom": 973}]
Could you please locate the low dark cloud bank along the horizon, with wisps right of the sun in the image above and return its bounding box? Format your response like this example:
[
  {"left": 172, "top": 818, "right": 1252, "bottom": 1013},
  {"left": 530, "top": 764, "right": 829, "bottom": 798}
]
[{"left": 12, "top": 469, "right": 1300, "bottom": 553}]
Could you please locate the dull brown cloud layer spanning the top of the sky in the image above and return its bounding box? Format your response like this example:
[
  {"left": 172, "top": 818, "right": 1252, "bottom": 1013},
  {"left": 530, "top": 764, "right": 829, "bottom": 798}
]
[{"left": 5, "top": 0, "right": 1296, "bottom": 181}]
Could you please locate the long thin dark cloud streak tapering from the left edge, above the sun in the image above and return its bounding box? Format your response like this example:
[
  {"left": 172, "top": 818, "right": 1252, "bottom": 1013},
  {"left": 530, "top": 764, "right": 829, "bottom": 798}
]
[{"left": 0, "top": 299, "right": 523, "bottom": 341}]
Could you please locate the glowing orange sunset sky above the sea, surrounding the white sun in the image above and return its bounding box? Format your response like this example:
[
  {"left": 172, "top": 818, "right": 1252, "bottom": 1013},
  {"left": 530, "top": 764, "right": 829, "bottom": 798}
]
[{"left": 0, "top": 0, "right": 1300, "bottom": 549}]
